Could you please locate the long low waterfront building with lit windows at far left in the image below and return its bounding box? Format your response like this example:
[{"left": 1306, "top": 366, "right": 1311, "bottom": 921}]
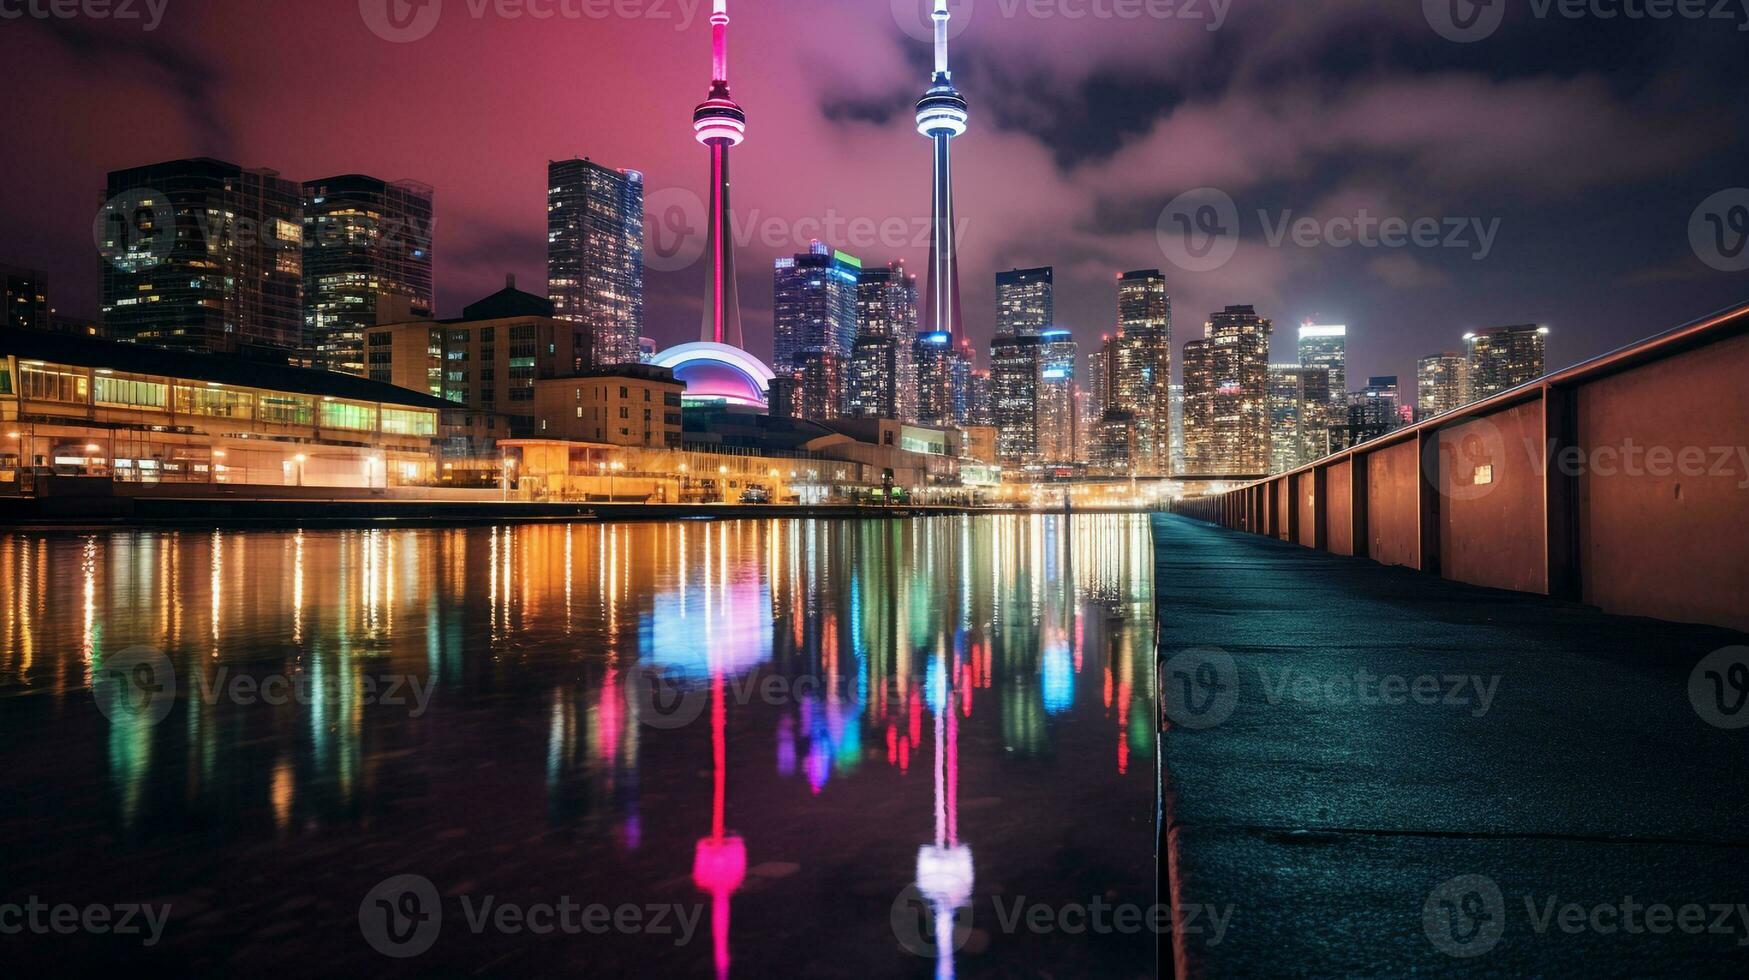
[{"left": 0, "top": 331, "right": 448, "bottom": 494}]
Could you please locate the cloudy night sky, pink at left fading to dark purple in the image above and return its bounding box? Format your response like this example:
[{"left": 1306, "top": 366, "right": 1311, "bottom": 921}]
[{"left": 0, "top": 0, "right": 1749, "bottom": 382}]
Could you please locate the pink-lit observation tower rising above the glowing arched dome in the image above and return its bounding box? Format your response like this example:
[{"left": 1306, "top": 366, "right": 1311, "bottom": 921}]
[{"left": 693, "top": 0, "right": 747, "bottom": 348}]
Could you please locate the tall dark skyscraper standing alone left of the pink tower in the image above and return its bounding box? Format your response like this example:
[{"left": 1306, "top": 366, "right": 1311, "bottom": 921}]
[{"left": 547, "top": 159, "right": 644, "bottom": 364}]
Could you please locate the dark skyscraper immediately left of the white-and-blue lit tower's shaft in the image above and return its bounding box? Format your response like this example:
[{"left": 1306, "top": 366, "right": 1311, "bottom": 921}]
[{"left": 850, "top": 263, "right": 916, "bottom": 422}]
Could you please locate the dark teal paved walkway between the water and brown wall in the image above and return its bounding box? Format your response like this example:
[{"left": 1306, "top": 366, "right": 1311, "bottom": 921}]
[{"left": 1154, "top": 516, "right": 1749, "bottom": 977}]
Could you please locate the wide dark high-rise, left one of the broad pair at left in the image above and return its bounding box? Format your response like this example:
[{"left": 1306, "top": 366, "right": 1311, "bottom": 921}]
[{"left": 98, "top": 158, "right": 306, "bottom": 352}]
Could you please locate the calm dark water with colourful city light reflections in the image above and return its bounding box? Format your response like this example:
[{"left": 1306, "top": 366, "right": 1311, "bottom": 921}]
[{"left": 0, "top": 515, "right": 1154, "bottom": 977}]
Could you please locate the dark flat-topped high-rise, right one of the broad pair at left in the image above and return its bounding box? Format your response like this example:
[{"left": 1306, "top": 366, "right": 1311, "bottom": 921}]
[{"left": 303, "top": 173, "right": 434, "bottom": 375}]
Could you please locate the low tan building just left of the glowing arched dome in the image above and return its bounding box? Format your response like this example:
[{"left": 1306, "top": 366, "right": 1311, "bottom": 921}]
[{"left": 533, "top": 364, "right": 686, "bottom": 448}]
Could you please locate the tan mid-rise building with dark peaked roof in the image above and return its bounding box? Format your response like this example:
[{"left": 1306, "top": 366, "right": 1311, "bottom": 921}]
[{"left": 366, "top": 277, "right": 595, "bottom": 457}]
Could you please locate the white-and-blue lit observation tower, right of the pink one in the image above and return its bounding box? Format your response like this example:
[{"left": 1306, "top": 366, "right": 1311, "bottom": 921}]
[{"left": 915, "top": 0, "right": 967, "bottom": 425}]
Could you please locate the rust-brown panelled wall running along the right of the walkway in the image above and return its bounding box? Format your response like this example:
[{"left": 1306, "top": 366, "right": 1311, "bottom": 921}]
[{"left": 1174, "top": 306, "right": 1749, "bottom": 630}]
